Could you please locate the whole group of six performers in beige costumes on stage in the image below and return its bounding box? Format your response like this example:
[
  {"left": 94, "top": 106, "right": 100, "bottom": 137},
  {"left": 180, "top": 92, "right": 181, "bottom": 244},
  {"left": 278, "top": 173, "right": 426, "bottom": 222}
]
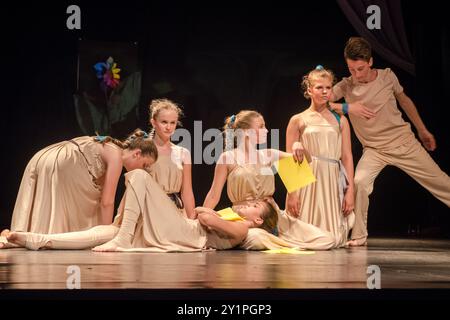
[{"left": 0, "top": 37, "right": 450, "bottom": 252}]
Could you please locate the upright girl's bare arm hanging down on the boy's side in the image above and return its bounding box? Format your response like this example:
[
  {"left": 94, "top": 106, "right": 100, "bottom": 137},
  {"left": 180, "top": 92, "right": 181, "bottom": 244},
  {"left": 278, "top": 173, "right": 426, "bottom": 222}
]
[{"left": 341, "top": 117, "right": 355, "bottom": 216}]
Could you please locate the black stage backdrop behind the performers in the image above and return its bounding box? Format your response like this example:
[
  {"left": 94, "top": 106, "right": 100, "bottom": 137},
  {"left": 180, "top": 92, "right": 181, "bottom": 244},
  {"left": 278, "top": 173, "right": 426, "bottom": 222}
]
[{"left": 0, "top": 0, "right": 450, "bottom": 237}]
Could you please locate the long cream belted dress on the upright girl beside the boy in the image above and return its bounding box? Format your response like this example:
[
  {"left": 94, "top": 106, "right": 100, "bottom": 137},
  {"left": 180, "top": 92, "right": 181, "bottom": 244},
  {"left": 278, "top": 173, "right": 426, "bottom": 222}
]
[{"left": 298, "top": 109, "right": 353, "bottom": 246}]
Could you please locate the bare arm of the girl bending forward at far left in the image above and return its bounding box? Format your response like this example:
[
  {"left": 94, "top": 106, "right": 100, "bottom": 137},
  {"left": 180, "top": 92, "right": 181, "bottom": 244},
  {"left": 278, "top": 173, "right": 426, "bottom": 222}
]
[{"left": 100, "top": 144, "right": 122, "bottom": 225}]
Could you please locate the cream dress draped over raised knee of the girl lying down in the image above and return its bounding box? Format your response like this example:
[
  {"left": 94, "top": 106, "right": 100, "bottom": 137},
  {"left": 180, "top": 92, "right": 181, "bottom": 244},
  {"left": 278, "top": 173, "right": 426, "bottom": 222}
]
[{"left": 110, "top": 169, "right": 207, "bottom": 252}]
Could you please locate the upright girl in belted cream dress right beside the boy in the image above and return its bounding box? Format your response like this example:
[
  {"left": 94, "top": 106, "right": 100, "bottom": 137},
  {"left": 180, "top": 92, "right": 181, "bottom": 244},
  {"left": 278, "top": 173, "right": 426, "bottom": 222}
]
[{"left": 286, "top": 66, "right": 355, "bottom": 246}]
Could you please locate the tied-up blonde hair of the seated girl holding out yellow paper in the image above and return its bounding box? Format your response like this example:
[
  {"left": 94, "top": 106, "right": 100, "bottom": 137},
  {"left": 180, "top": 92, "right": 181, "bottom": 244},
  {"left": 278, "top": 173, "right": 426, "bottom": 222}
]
[{"left": 223, "top": 110, "right": 263, "bottom": 150}]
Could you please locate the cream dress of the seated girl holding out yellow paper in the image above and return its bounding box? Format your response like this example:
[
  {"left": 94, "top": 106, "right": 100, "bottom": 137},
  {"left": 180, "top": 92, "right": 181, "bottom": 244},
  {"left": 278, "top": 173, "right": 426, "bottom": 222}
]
[{"left": 227, "top": 152, "right": 340, "bottom": 250}]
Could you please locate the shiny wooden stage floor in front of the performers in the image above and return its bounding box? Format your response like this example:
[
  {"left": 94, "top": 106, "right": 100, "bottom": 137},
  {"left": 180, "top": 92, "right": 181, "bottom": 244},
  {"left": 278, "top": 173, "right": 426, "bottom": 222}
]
[{"left": 0, "top": 238, "right": 450, "bottom": 294}]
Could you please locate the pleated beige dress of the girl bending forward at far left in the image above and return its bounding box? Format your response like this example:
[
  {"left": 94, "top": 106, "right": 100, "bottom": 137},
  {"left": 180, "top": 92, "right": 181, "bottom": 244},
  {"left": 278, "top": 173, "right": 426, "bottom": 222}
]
[{"left": 11, "top": 137, "right": 106, "bottom": 233}]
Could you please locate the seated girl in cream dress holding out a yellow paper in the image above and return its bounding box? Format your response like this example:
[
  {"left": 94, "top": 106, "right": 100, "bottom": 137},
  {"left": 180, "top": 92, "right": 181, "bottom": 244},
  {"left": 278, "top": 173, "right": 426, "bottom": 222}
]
[{"left": 203, "top": 110, "right": 348, "bottom": 250}]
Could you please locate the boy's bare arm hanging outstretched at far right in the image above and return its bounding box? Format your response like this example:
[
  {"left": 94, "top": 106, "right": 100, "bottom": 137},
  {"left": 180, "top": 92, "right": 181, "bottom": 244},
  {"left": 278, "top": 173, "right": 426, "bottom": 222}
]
[{"left": 395, "top": 92, "right": 436, "bottom": 151}]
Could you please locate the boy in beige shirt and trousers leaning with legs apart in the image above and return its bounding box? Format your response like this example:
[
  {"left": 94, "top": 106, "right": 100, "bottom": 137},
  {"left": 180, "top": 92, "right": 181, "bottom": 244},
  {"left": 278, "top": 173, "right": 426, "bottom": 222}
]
[{"left": 331, "top": 37, "right": 450, "bottom": 246}]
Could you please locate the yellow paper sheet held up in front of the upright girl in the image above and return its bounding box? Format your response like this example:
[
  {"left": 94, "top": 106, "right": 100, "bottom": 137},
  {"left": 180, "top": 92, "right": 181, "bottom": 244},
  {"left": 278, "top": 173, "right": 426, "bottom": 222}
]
[{"left": 275, "top": 156, "right": 316, "bottom": 193}]
